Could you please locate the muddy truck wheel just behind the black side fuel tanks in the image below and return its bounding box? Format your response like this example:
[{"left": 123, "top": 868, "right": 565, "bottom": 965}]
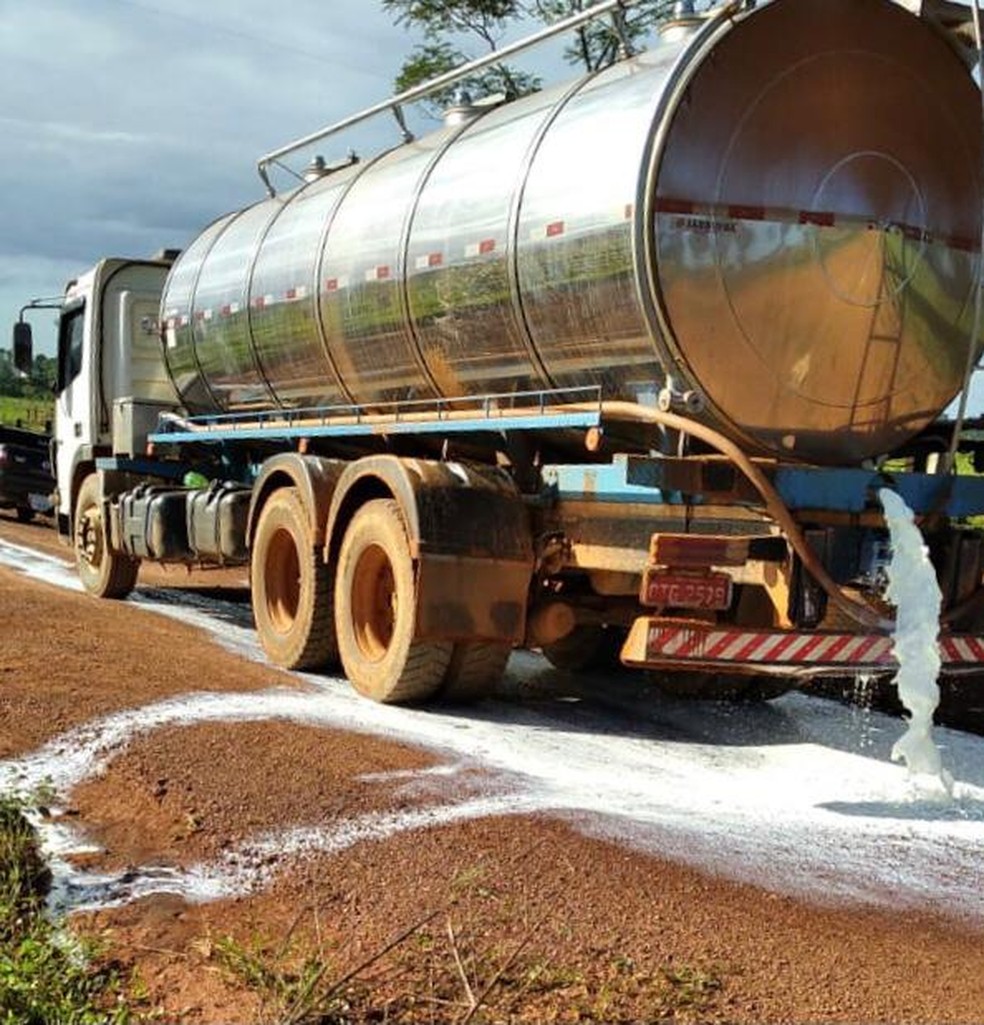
[{"left": 250, "top": 488, "right": 338, "bottom": 669}]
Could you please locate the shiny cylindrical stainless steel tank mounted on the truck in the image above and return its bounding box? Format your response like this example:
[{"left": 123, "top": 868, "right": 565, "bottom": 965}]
[{"left": 162, "top": 0, "right": 982, "bottom": 463}]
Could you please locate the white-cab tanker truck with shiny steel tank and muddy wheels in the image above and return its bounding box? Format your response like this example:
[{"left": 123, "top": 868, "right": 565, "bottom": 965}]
[{"left": 14, "top": 0, "right": 984, "bottom": 702}]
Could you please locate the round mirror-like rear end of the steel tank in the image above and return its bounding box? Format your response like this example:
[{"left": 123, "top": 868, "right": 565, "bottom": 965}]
[{"left": 646, "top": 0, "right": 982, "bottom": 462}]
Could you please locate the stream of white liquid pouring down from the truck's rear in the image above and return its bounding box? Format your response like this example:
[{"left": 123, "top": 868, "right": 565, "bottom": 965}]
[{"left": 878, "top": 488, "right": 953, "bottom": 794}]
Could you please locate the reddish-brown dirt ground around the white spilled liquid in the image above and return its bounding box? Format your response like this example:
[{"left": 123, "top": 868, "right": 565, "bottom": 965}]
[{"left": 0, "top": 516, "right": 984, "bottom": 1023}]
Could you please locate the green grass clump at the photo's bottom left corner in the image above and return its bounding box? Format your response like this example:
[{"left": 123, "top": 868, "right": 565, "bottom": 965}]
[{"left": 0, "top": 794, "right": 133, "bottom": 1025}]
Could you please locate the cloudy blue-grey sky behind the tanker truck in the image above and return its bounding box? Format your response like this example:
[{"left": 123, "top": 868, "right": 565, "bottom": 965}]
[{"left": 0, "top": 0, "right": 984, "bottom": 413}]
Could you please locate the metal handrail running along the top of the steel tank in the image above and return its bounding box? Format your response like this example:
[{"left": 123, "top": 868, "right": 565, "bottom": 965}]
[{"left": 256, "top": 0, "right": 664, "bottom": 197}]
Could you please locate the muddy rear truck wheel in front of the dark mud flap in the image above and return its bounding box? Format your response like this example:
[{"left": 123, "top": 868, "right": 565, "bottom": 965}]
[{"left": 335, "top": 498, "right": 454, "bottom": 704}]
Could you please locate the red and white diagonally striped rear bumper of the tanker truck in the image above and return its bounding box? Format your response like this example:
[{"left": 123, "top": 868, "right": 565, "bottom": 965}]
[{"left": 622, "top": 616, "right": 984, "bottom": 675}]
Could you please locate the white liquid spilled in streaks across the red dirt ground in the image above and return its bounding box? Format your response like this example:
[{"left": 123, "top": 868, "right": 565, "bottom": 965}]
[{"left": 0, "top": 546, "right": 984, "bottom": 919}]
